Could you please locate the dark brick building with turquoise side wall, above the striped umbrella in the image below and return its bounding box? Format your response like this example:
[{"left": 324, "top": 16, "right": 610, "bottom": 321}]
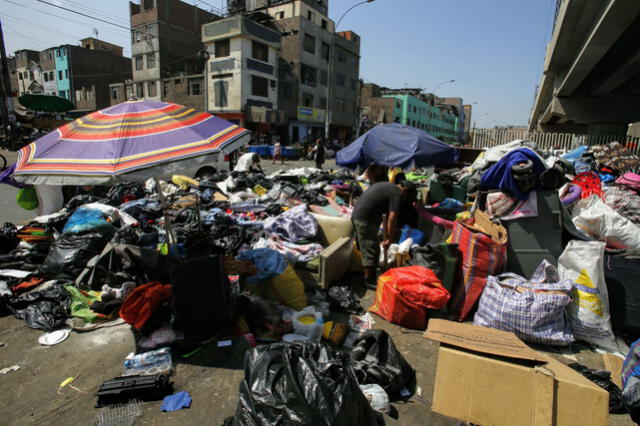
[{"left": 55, "top": 39, "right": 131, "bottom": 110}]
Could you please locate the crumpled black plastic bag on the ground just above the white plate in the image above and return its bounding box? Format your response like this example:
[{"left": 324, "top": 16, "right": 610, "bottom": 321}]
[{"left": 7, "top": 282, "right": 71, "bottom": 331}]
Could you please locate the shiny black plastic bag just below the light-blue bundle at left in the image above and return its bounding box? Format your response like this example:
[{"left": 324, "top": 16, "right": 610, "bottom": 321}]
[{"left": 42, "top": 228, "right": 115, "bottom": 279}]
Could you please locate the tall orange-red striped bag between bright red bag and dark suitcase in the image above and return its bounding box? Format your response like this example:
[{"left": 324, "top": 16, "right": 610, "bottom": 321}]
[{"left": 449, "top": 216, "right": 507, "bottom": 321}]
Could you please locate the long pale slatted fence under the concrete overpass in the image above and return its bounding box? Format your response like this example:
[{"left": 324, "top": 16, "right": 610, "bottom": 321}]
[{"left": 471, "top": 129, "right": 640, "bottom": 154}]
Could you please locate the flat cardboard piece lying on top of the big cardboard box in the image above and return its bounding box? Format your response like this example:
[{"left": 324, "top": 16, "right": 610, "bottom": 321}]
[{"left": 424, "top": 319, "right": 547, "bottom": 363}]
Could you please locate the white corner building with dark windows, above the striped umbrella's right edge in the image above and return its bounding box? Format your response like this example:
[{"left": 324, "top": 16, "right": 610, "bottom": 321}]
[{"left": 202, "top": 14, "right": 284, "bottom": 133}]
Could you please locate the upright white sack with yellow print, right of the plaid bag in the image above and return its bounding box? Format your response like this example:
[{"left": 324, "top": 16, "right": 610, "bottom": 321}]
[{"left": 558, "top": 240, "right": 618, "bottom": 350}]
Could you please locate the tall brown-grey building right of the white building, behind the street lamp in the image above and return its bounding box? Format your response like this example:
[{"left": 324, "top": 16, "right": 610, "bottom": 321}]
[{"left": 228, "top": 0, "right": 360, "bottom": 142}]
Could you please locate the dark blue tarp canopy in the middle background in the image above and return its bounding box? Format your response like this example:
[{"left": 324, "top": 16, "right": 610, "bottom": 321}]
[{"left": 336, "top": 123, "right": 458, "bottom": 169}]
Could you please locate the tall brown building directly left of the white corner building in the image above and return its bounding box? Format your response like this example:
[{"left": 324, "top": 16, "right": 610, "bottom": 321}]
[{"left": 124, "top": 0, "right": 220, "bottom": 110}]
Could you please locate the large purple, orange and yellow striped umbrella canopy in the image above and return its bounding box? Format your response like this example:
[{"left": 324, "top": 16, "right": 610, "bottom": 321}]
[{"left": 14, "top": 101, "right": 250, "bottom": 185}]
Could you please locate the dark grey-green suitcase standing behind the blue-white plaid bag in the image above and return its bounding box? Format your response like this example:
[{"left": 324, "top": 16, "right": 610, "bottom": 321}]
[{"left": 502, "top": 191, "right": 563, "bottom": 279}]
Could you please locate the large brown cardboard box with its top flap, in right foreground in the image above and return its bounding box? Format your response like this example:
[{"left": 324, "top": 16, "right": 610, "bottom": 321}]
[{"left": 424, "top": 319, "right": 609, "bottom": 426}]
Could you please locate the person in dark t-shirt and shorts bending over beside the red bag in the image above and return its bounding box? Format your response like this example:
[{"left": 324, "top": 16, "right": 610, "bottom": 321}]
[{"left": 351, "top": 165, "right": 402, "bottom": 288}]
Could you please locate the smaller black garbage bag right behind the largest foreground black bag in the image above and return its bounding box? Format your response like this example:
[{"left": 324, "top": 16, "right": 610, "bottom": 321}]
[{"left": 351, "top": 330, "right": 416, "bottom": 398}]
